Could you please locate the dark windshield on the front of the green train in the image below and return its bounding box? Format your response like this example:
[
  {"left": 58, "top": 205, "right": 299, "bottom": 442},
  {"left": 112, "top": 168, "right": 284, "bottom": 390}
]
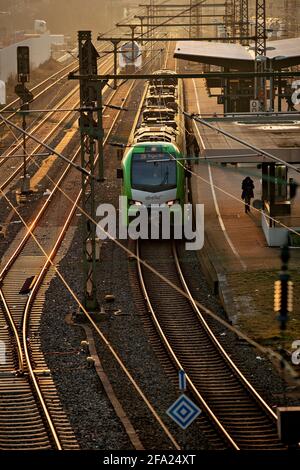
[{"left": 131, "top": 153, "right": 176, "bottom": 192}]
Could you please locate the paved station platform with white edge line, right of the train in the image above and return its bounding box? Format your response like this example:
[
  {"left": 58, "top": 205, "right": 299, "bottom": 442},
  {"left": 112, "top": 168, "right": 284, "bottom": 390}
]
[{"left": 185, "top": 79, "right": 300, "bottom": 350}]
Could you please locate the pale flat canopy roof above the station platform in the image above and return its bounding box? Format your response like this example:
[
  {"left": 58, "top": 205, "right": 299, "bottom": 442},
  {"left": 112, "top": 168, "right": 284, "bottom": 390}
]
[{"left": 174, "top": 38, "right": 300, "bottom": 70}]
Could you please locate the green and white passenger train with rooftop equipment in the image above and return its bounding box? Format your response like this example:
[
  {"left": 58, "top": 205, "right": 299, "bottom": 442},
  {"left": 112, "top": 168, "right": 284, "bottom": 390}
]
[{"left": 118, "top": 70, "right": 185, "bottom": 223}]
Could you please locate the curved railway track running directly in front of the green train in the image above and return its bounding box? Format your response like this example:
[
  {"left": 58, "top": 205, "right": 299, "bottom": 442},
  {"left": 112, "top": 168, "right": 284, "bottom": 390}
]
[{"left": 137, "top": 241, "right": 283, "bottom": 450}]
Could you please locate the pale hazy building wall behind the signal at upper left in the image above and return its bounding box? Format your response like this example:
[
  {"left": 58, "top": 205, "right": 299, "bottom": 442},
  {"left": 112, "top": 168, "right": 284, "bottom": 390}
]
[{"left": 0, "top": 33, "right": 51, "bottom": 82}]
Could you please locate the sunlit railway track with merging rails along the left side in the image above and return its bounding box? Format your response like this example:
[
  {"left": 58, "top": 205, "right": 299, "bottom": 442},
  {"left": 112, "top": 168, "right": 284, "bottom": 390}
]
[{"left": 0, "top": 71, "right": 135, "bottom": 450}]
